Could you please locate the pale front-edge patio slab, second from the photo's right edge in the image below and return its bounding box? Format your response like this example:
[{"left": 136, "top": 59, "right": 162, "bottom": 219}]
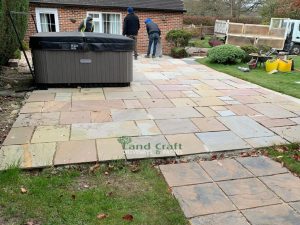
[{"left": 245, "top": 136, "right": 288, "bottom": 148}]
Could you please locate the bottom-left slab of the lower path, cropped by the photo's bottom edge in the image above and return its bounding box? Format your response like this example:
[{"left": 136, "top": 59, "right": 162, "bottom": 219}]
[{"left": 190, "top": 211, "right": 250, "bottom": 225}]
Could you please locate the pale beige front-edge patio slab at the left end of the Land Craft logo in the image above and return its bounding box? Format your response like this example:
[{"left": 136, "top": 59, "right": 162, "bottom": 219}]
[{"left": 96, "top": 138, "right": 125, "bottom": 162}]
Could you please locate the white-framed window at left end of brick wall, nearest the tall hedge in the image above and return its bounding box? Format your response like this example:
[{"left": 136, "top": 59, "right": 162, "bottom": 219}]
[{"left": 36, "top": 8, "right": 59, "bottom": 32}]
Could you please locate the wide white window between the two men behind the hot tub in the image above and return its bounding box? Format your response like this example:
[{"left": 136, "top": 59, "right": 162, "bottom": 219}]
[{"left": 87, "top": 12, "right": 122, "bottom": 34}]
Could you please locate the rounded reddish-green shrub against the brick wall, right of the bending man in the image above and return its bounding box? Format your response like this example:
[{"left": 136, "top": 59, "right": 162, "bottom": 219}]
[{"left": 166, "top": 30, "right": 192, "bottom": 47}]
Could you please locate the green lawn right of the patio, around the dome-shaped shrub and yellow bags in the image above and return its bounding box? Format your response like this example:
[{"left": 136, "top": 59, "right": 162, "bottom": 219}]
[{"left": 197, "top": 56, "right": 300, "bottom": 98}]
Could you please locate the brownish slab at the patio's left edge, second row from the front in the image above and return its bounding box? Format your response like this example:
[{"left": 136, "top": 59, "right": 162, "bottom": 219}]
[{"left": 3, "top": 127, "right": 34, "bottom": 145}]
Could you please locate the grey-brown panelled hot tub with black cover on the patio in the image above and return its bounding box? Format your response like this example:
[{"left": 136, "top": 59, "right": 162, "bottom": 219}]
[{"left": 30, "top": 32, "right": 134, "bottom": 86}]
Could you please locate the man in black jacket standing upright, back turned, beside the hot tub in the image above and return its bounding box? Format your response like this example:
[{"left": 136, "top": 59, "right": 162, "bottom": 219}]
[{"left": 123, "top": 7, "right": 140, "bottom": 60}]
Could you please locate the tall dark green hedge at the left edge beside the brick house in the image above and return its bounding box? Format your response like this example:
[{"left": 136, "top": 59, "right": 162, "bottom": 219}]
[{"left": 0, "top": 0, "right": 29, "bottom": 65}]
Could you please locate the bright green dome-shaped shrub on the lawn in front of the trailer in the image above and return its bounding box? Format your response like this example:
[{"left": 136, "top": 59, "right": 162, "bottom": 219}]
[{"left": 208, "top": 45, "right": 246, "bottom": 64}]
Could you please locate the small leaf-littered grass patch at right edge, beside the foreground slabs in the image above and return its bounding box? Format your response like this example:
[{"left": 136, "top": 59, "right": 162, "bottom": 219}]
[{"left": 267, "top": 144, "right": 300, "bottom": 176}]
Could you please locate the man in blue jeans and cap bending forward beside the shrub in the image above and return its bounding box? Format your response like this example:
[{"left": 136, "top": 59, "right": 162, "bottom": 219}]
[{"left": 145, "top": 18, "right": 161, "bottom": 58}]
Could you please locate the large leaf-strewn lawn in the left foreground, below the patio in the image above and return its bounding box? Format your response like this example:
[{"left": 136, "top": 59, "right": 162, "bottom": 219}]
[{"left": 0, "top": 161, "right": 187, "bottom": 225}]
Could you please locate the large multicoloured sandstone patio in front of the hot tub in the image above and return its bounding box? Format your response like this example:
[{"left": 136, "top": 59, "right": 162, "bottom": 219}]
[{"left": 0, "top": 58, "right": 300, "bottom": 169}]
